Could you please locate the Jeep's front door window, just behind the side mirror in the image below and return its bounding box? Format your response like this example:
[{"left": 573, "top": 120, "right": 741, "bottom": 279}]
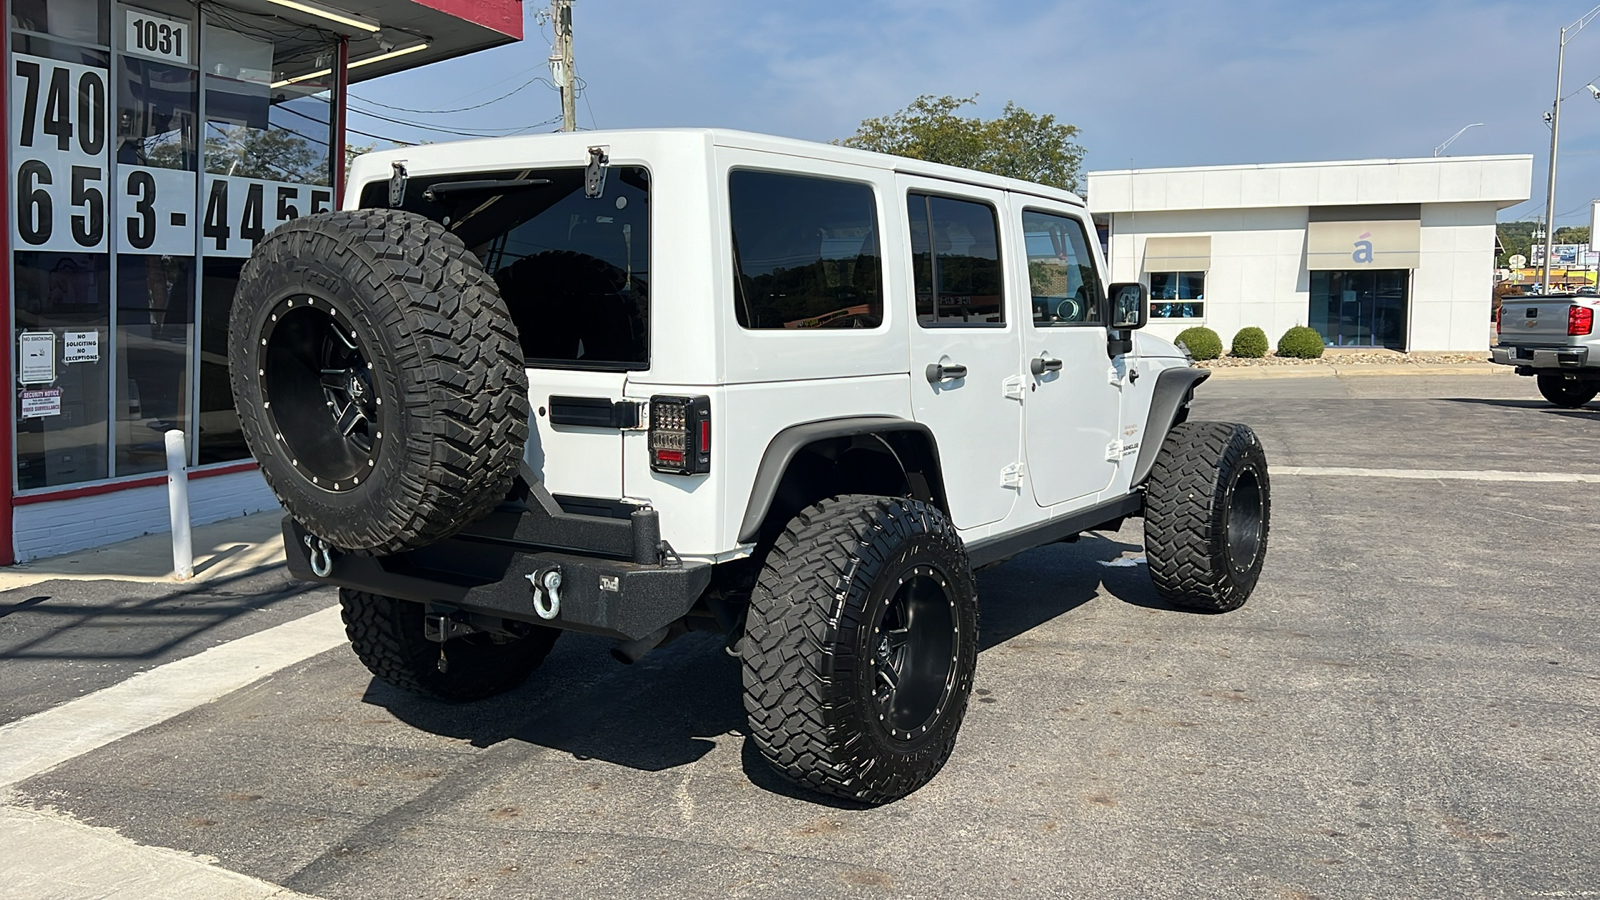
[{"left": 1022, "top": 210, "right": 1104, "bottom": 327}]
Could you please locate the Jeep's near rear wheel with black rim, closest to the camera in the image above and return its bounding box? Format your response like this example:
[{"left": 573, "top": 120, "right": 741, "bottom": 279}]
[{"left": 742, "top": 495, "right": 978, "bottom": 804}]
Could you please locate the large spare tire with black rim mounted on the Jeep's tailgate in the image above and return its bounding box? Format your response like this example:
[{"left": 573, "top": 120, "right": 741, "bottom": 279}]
[{"left": 229, "top": 210, "right": 528, "bottom": 554}]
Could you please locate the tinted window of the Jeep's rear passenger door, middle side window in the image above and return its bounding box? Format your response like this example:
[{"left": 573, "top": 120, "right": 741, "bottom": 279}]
[{"left": 906, "top": 194, "right": 1005, "bottom": 325}]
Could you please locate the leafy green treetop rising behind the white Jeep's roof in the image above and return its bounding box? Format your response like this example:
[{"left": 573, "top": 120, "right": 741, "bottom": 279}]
[{"left": 835, "top": 94, "right": 1083, "bottom": 191}]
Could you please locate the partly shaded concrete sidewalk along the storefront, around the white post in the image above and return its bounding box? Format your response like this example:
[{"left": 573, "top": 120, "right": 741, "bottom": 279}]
[{"left": 0, "top": 509, "right": 283, "bottom": 591}]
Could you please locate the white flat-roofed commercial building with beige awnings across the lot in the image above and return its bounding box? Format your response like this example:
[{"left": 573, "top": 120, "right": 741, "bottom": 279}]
[{"left": 1088, "top": 155, "right": 1533, "bottom": 354}]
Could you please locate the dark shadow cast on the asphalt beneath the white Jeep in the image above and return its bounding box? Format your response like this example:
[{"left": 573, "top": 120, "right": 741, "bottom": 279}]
[{"left": 362, "top": 535, "right": 1166, "bottom": 809}]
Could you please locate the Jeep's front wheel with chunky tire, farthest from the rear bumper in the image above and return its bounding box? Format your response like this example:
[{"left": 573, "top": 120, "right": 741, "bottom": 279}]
[{"left": 1144, "top": 421, "right": 1272, "bottom": 612}]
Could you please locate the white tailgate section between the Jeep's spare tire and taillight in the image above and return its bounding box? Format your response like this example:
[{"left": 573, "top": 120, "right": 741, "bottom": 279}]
[{"left": 526, "top": 368, "right": 635, "bottom": 500}]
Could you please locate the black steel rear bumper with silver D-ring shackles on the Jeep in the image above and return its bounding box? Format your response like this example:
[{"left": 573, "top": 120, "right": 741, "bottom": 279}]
[{"left": 283, "top": 516, "right": 712, "bottom": 641}]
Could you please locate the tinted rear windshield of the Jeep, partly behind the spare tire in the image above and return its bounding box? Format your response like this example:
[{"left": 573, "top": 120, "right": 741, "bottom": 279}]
[{"left": 362, "top": 167, "right": 650, "bottom": 370}]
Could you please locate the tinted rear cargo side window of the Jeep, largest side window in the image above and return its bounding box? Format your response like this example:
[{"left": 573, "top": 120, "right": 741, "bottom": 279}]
[{"left": 728, "top": 170, "right": 883, "bottom": 328}]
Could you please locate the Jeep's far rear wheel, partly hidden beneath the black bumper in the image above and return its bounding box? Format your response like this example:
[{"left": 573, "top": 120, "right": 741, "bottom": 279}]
[{"left": 339, "top": 588, "right": 562, "bottom": 703}]
